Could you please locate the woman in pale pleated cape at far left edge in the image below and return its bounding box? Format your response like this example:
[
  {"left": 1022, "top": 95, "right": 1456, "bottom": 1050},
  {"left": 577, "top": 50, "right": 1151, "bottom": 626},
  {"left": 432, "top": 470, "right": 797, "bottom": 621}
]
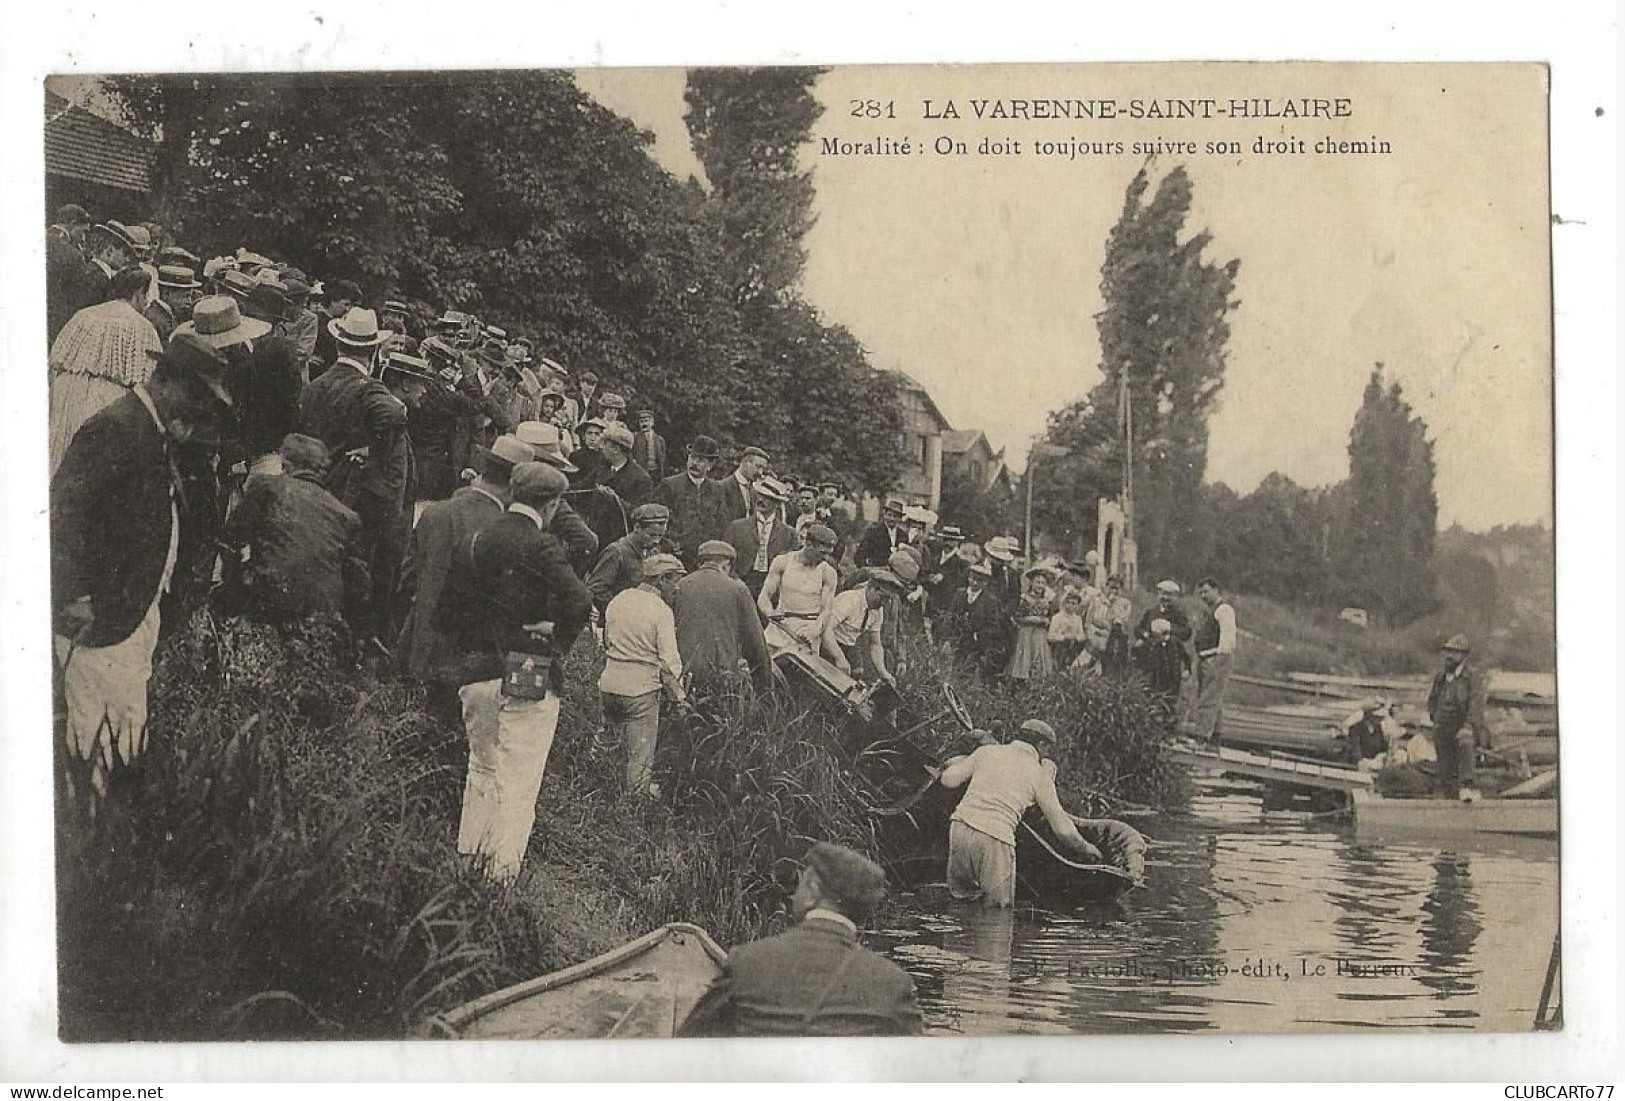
[{"left": 49, "top": 266, "right": 164, "bottom": 474}]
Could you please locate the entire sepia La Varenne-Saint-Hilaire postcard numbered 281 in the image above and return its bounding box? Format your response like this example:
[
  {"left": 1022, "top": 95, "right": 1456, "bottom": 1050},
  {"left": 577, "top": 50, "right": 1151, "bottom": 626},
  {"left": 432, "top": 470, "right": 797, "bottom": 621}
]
[{"left": 39, "top": 56, "right": 1565, "bottom": 1044}]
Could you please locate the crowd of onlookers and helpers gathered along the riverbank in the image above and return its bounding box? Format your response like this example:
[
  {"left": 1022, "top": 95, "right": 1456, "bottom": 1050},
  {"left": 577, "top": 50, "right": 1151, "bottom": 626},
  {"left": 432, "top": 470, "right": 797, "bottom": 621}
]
[{"left": 47, "top": 206, "right": 1254, "bottom": 1032}]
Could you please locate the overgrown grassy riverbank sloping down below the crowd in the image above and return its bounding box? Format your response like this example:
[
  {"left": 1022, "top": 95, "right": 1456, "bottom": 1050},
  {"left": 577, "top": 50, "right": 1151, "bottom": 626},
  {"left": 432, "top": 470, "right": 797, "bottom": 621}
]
[{"left": 57, "top": 617, "right": 1172, "bottom": 1041}]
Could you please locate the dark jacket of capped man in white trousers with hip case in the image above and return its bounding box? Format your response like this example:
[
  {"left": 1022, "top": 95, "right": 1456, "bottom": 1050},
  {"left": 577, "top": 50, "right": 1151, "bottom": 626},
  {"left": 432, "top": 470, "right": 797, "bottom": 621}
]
[{"left": 437, "top": 512, "right": 590, "bottom": 693}]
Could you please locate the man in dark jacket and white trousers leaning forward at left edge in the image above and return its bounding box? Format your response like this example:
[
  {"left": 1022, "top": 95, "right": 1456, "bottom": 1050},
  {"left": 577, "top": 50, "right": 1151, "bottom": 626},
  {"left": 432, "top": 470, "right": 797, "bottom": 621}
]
[{"left": 50, "top": 335, "right": 231, "bottom": 791}]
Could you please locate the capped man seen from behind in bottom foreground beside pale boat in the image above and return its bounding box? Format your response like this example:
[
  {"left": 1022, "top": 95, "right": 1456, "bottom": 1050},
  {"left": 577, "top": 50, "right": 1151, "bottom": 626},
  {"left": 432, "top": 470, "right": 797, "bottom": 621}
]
[{"left": 678, "top": 841, "right": 920, "bottom": 1036}]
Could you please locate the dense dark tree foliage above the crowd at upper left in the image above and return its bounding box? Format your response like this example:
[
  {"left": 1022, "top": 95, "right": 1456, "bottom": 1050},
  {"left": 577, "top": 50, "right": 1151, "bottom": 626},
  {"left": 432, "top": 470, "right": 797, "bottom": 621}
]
[{"left": 109, "top": 70, "right": 900, "bottom": 489}]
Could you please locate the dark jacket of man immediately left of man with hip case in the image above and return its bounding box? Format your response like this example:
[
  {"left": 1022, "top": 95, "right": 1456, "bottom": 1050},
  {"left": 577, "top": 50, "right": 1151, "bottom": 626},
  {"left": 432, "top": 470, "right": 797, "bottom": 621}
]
[{"left": 395, "top": 486, "right": 504, "bottom": 680}]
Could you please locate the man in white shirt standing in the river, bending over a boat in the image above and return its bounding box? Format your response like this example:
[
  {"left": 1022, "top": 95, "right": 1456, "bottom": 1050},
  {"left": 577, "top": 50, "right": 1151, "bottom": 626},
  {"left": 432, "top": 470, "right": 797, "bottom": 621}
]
[{"left": 939, "top": 719, "right": 1102, "bottom": 906}]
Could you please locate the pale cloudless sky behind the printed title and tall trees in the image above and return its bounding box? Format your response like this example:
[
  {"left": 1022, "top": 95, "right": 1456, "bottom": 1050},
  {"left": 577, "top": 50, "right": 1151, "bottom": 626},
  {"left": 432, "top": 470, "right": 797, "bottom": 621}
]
[{"left": 577, "top": 63, "right": 1552, "bottom": 529}]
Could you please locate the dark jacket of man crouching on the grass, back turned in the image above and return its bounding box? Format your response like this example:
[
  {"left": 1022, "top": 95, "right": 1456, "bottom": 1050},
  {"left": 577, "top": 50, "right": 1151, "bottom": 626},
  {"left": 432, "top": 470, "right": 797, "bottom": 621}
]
[{"left": 224, "top": 471, "right": 369, "bottom": 622}]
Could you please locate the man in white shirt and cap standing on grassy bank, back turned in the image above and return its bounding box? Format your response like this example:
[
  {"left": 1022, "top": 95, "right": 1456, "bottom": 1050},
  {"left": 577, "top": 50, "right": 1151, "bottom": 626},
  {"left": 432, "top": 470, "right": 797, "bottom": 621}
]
[{"left": 598, "top": 554, "right": 686, "bottom": 799}]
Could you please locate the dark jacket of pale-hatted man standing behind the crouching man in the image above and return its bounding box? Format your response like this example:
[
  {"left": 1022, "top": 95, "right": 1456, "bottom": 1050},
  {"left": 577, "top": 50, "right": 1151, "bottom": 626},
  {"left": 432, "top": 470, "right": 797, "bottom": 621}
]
[{"left": 299, "top": 364, "right": 406, "bottom": 516}]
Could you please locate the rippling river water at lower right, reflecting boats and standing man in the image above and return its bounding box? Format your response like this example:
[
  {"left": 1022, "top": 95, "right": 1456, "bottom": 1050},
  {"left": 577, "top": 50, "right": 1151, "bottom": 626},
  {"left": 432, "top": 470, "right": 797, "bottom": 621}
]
[{"left": 871, "top": 776, "right": 1558, "bottom": 1034}]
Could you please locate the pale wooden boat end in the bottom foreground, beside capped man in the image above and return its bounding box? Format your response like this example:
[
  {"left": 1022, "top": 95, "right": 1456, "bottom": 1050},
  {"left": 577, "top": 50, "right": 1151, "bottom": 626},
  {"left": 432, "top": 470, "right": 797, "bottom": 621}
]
[{"left": 429, "top": 922, "right": 728, "bottom": 1039}]
